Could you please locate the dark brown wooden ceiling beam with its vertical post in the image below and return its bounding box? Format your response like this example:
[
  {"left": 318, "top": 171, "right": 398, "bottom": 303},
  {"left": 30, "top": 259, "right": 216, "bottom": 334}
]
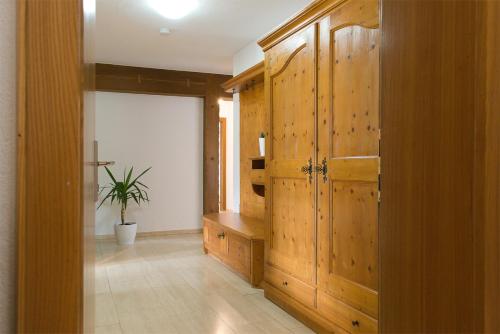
[{"left": 96, "top": 64, "right": 232, "bottom": 213}]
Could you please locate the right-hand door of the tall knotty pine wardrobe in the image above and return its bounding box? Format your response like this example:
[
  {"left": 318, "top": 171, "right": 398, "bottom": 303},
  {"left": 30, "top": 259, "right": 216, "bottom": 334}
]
[{"left": 318, "top": 0, "right": 380, "bottom": 323}]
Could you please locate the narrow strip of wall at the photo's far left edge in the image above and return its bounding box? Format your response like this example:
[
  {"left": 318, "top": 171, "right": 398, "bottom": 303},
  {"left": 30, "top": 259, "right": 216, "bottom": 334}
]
[{"left": 0, "top": 0, "right": 16, "bottom": 333}]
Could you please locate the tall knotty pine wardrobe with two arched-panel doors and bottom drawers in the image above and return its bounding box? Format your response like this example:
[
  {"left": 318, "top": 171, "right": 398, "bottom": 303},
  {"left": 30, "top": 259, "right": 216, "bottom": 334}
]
[{"left": 260, "top": 0, "right": 380, "bottom": 333}]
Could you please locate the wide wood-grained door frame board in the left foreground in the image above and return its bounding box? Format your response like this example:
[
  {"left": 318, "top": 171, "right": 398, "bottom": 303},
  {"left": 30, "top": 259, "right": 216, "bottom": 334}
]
[{"left": 18, "top": 0, "right": 85, "bottom": 333}]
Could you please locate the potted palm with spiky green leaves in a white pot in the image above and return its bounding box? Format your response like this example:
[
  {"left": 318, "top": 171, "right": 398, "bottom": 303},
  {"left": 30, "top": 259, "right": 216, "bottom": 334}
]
[{"left": 97, "top": 167, "right": 151, "bottom": 245}]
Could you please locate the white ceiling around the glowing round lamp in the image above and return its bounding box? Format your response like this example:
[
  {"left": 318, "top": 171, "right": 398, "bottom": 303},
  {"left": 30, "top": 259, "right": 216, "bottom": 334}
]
[{"left": 96, "top": 0, "right": 311, "bottom": 74}]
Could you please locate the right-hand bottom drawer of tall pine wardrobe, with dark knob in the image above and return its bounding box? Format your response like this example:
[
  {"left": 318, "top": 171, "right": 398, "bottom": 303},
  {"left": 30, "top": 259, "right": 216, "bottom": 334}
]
[{"left": 318, "top": 291, "right": 378, "bottom": 333}]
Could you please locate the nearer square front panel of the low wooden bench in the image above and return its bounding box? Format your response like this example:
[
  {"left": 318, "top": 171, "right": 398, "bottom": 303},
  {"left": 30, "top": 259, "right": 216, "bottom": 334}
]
[{"left": 225, "top": 233, "right": 251, "bottom": 278}]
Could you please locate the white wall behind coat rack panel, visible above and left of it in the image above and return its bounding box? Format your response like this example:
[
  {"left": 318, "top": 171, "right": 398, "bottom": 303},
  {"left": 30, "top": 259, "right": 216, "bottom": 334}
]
[{"left": 233, "top": 42, "right": 264, "bottom": 212}]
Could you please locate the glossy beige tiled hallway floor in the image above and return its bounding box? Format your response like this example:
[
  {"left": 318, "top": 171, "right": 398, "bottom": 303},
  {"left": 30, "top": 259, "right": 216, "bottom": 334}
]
[{"left": 96, "top": 235, "right": 312, "bottom": 334}]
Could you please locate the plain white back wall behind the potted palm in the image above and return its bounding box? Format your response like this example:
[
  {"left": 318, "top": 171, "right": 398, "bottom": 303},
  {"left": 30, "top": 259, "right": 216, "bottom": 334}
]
[{"left": 96, "top": 92, "right": 203, "bottom": 235}]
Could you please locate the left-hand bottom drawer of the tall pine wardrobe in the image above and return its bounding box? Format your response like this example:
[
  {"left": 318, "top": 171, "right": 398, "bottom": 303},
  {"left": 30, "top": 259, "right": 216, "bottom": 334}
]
[{"left": 264, "top": 266, "right": 316, "bottom": 308}]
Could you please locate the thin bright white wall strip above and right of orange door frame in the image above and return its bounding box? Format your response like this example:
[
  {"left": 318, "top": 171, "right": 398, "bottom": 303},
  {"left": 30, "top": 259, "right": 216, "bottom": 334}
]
[{"left": 219, "top": 100, "right": 234, "bottom": 211}]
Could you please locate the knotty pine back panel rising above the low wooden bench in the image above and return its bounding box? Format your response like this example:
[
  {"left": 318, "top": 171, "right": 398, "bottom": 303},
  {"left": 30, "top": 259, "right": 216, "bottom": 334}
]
[{"left": 240, "top": 83, "right": 265, "bottom": 219}]
